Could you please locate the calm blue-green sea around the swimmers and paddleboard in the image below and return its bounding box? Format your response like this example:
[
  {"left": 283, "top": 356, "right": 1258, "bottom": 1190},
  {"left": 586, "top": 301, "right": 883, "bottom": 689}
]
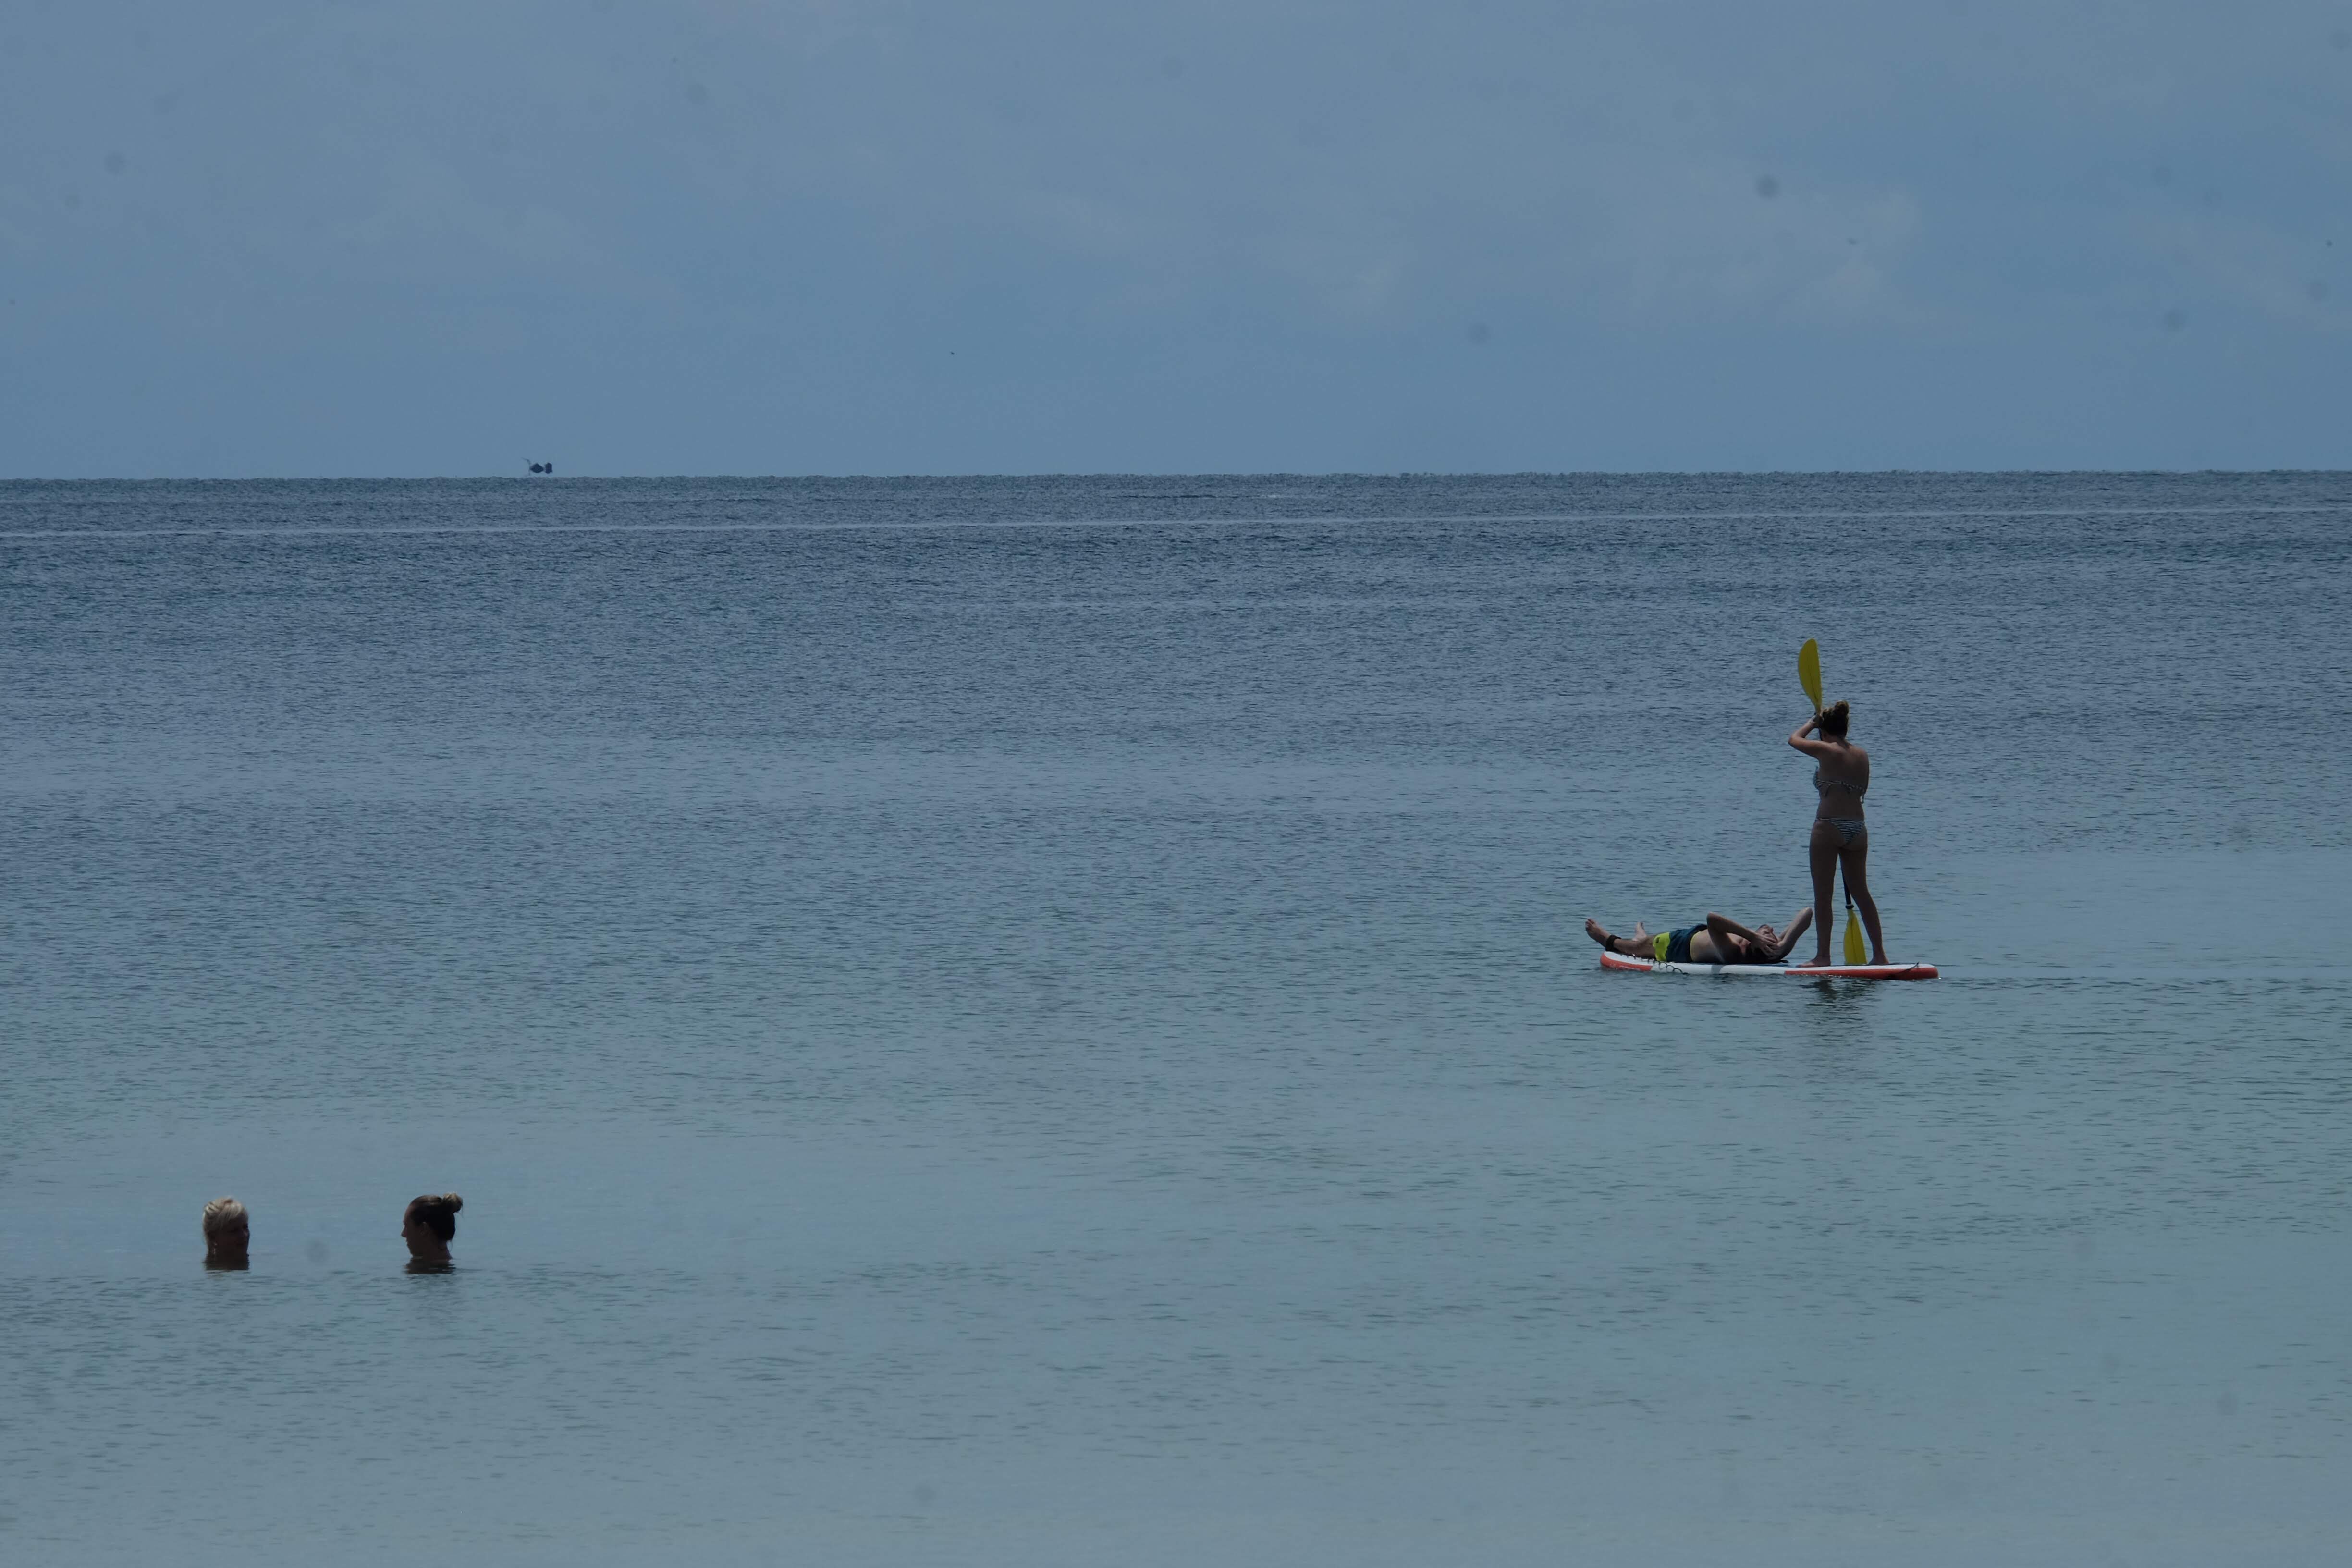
[{"left": 0, "top": 473, "right": 2352, "bottom": 1568}]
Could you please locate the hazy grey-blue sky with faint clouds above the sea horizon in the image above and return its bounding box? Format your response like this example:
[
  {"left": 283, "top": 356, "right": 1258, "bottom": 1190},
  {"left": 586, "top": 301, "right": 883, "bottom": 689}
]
[{"left": 0, "top": 0, "right": 2352, "bottom": 477}]
